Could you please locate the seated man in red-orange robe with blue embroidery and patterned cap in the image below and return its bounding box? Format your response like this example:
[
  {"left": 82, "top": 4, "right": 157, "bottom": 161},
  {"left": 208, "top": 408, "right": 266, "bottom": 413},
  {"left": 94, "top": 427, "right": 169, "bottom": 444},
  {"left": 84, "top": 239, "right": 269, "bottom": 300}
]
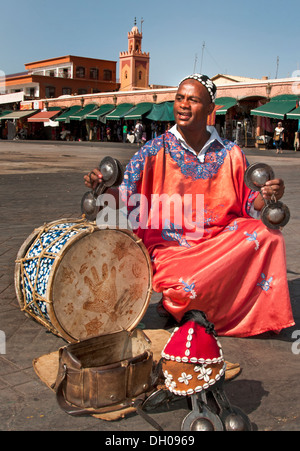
[{"left": 85, "top": 74, "right": 294, "bottom": 337}]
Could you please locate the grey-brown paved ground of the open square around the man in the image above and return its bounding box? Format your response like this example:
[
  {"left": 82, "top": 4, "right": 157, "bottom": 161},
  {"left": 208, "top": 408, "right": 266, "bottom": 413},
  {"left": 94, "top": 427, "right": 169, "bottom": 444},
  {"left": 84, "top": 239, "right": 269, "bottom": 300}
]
[{"left": 0, "top": 141, "right": 300, "bottom": 433}]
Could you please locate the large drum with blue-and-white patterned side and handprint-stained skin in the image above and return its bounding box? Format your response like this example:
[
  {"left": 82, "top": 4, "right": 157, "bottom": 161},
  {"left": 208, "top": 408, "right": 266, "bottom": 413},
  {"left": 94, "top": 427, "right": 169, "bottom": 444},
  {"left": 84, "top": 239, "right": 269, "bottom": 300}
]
[{"left": 15, "top": 219, "right": 152, "bottom": 342}]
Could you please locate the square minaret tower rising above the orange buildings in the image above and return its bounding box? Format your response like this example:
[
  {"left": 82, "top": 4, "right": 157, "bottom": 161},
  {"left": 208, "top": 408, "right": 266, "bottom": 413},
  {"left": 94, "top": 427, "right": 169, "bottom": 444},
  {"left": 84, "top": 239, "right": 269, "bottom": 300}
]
[{"left": 119, "top": 19, "right": 150, "bottom": 91}]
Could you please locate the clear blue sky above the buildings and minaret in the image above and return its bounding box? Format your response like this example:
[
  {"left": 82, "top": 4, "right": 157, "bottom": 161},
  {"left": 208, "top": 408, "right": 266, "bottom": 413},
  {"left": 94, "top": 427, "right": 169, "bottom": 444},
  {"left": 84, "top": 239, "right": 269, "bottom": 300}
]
[{"left": 0, "top": 0, "right": 300, "bottom": 85}]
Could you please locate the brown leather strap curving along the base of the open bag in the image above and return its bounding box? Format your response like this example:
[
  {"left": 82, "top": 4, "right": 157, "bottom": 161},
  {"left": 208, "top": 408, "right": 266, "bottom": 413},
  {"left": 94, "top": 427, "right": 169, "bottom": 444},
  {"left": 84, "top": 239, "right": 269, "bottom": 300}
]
[{"left": 55, "top": 365, "right": 163, "bottom": 431}]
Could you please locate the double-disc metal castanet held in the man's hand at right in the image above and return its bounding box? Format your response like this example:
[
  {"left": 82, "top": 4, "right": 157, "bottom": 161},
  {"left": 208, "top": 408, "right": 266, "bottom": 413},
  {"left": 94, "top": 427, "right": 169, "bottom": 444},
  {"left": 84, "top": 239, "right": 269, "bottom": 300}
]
[{"left": 244, "top": 163, "right": 290, "bottom": 229}]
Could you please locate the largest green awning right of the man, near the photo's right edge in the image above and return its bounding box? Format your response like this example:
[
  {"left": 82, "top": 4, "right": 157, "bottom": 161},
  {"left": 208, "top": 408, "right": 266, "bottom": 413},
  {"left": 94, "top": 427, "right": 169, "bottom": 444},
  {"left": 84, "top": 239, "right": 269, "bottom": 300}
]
[{"left": 251, "top": 94, "right": 297, "bottom": 119}]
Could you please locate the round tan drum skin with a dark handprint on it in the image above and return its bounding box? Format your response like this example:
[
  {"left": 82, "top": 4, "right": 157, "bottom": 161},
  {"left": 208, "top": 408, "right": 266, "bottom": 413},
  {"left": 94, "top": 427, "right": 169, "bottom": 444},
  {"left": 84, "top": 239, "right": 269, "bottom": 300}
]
[{"left": 48, "top": 229, "right": 152, "bottom": 341}]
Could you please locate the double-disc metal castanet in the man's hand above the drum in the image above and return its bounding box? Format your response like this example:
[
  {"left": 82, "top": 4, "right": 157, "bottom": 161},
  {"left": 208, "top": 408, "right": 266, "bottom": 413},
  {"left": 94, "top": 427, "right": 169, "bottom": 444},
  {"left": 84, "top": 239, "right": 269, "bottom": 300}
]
[{"left": 81, "top": 156, "right": 124, "bottom": 221}]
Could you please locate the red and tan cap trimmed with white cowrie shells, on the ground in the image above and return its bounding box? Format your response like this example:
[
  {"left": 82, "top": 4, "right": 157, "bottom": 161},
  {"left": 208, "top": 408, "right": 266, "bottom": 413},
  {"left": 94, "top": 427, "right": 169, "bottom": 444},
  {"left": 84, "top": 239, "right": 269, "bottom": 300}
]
[{"left": 162, "top": 311, "right": 226, "bottom": 396}]
